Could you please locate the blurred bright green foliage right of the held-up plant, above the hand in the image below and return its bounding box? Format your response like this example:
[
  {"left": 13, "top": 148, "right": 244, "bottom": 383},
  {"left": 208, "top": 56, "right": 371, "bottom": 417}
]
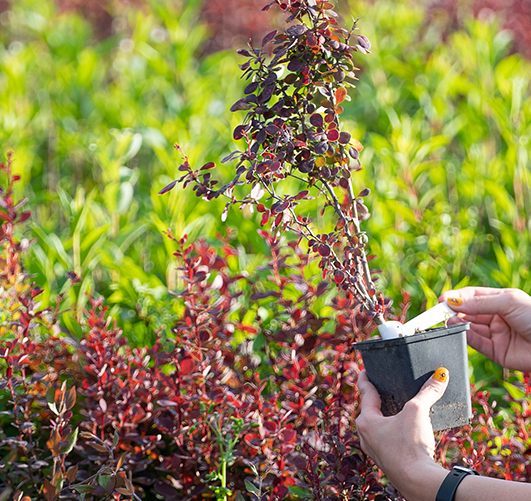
[{"left": 346, "top": 1, "right": 531, "bottom": 313}]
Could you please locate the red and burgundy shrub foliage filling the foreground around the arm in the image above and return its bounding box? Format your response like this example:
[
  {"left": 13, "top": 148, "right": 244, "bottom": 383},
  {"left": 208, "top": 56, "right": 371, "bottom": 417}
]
[{"left": 0, "top": 148, "right": 531, "bottom": 501}]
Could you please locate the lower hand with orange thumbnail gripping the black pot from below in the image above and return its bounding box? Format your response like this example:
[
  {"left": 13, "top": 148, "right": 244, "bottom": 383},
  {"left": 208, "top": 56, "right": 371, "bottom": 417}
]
[{"left": 356, "top": 367, "right": 448, "bottom": 500}]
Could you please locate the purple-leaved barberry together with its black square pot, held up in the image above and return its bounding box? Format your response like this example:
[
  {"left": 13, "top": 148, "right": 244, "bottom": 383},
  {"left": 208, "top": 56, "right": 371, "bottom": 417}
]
[{"left": 160, "top": 0, "right": 471, "bottom": 429}]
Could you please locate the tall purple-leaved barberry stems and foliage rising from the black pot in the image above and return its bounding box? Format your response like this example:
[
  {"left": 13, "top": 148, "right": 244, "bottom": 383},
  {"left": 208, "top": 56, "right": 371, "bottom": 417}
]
[{"left": 160, "top": 0, "right": 385, "bottom": 324}]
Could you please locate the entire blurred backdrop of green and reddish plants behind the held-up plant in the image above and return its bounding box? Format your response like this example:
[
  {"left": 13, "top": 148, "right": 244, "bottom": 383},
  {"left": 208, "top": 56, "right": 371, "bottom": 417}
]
[{"left": 0, "top": 0, "right": 531, "bottom": 495}]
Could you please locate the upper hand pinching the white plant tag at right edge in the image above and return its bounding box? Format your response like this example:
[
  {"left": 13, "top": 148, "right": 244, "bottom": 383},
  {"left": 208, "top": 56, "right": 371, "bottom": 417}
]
[{"left": 439, "top": 287, "right": 531, "bottom": 372}]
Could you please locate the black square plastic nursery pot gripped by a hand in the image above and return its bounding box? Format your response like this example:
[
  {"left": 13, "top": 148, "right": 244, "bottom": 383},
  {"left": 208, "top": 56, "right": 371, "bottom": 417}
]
[{"left": 354, "top": 324, "right": 472, "bottom": 431}]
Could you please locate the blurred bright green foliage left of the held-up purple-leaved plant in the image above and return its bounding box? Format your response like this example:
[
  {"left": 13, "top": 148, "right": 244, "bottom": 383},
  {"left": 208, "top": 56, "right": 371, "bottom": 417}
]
[{"left": 0, "top": 1, "right": 258, "bottom": 342}]
